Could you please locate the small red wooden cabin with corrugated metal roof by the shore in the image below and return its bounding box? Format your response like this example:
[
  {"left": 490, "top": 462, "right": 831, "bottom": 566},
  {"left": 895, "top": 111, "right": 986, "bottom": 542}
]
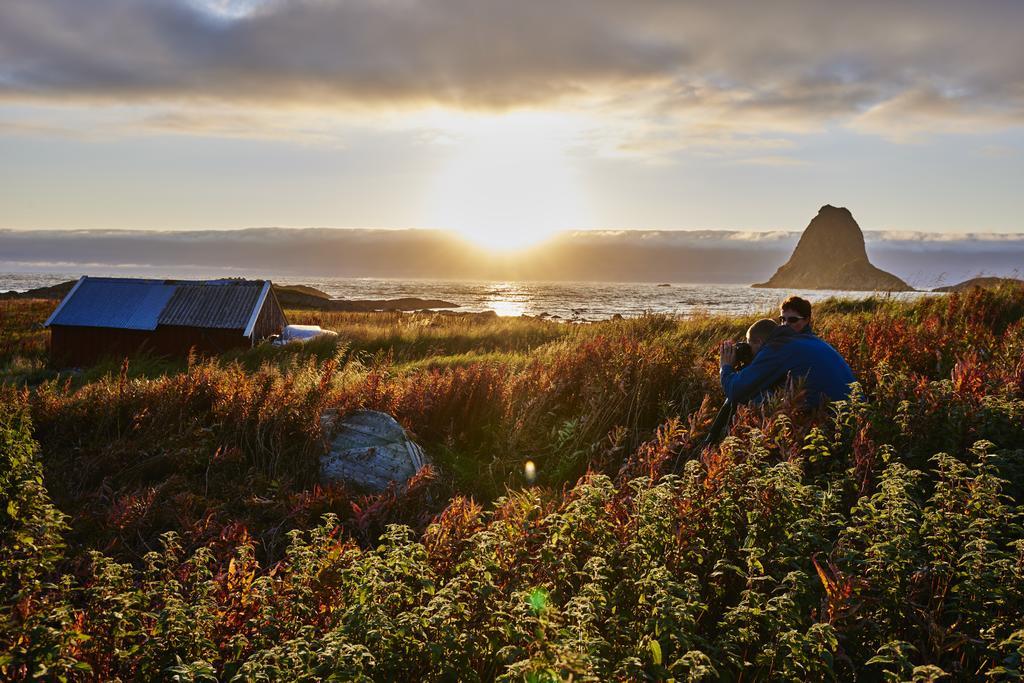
[{"left": 45, "top": 276, "right": 288, "bottom": 367}]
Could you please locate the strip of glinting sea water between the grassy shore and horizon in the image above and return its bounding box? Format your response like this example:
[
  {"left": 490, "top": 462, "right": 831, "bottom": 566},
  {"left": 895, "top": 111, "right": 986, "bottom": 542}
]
[{"left": 0, "top": 268, "right": 925, "bottom": 322}]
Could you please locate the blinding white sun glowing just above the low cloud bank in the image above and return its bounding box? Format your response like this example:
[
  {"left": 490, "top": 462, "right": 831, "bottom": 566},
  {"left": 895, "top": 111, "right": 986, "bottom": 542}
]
[{"left": 430, "top": 114, "right": 586, "bottom": 251}]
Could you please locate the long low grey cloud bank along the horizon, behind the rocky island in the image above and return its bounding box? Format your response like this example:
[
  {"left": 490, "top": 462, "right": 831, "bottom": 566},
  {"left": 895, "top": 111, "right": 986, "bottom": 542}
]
[{"left": 0, "top": 228, "right": 1024, "bottom": 289}]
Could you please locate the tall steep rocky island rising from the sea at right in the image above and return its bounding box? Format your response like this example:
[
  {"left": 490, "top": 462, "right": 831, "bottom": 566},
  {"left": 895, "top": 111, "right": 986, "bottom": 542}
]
[{"left": 753, "top": 204, "right": 913, "bottom": 292}]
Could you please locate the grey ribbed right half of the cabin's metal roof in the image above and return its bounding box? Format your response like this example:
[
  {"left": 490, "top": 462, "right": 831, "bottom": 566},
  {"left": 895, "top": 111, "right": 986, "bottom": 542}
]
[{"left": 160, "top": 281, "right": 263, "bottom": 330}]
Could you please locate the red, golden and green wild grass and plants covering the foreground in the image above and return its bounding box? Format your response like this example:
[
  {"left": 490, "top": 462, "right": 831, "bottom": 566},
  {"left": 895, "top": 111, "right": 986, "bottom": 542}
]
[{"left": 0, "top": 289, "right": 1024, "bottom": 681}]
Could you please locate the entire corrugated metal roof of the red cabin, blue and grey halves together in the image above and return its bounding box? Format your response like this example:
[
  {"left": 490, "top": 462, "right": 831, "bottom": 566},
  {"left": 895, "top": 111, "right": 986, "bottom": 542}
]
[{"left": 46, "top": 278, "right": 266, "bottom": 330}]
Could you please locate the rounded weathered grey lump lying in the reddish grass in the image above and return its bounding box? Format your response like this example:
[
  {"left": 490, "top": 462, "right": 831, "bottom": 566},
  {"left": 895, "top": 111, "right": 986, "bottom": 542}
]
[{"left": 321, "top": 411, "right": 429, "bottom": 492}]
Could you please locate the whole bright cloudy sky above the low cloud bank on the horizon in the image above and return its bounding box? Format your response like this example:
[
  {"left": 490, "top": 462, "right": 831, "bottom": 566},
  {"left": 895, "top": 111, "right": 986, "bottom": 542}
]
[{"left": 0, "top": 0, "right": 1024, "bottom": 249}]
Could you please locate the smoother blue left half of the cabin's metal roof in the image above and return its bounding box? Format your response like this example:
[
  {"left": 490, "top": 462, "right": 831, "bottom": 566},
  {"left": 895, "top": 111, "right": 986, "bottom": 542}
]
[{"left": 47, "top": 278, "right": 174, "bottom": 330}]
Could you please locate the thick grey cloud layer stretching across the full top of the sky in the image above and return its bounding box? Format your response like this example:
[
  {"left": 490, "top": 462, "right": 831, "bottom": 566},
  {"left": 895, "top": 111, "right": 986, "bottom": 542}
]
[{"left": 0, "top": 0, "right": 1024, "bottom": 144}]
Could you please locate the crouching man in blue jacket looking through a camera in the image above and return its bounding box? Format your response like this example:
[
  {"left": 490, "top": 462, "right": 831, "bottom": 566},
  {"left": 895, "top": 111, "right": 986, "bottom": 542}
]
[{"left": 720, "top": 318, "right": 854, "bottom": 408}]
